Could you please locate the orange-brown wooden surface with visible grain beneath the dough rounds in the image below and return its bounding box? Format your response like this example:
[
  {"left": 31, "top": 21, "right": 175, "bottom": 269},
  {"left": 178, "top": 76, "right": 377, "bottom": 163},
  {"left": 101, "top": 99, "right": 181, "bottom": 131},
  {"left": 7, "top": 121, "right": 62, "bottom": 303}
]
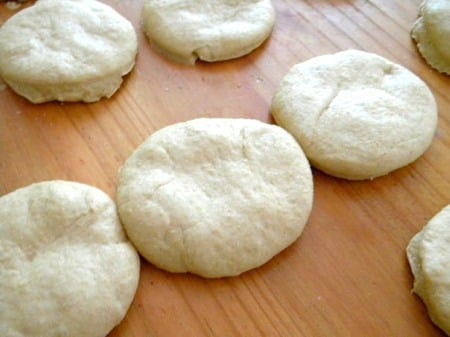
[{"left": 0, "top": 0, "right": 450, "bottom": 337}]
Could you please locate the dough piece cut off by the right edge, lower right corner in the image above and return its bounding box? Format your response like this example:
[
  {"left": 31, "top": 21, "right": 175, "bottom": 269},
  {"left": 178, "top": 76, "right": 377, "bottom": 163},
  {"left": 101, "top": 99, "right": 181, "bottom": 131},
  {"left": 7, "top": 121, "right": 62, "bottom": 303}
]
[{"left": 407, "top": 205, "right": 450, "bottom": 336}]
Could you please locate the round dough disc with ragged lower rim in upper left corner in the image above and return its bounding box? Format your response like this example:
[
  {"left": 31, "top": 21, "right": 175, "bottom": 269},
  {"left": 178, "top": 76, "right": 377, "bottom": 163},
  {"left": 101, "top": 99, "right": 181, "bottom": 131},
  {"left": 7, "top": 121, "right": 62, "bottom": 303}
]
[{"left": 0, "top": 0, "right": 137, "bottom": 103}]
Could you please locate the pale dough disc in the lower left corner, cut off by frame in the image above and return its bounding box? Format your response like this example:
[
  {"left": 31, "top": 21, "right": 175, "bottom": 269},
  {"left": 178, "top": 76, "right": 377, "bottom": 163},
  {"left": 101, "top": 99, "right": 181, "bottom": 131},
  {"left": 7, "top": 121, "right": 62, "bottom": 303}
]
[{"left": 0, "top": 181, "right": 140, "bottom": 337}]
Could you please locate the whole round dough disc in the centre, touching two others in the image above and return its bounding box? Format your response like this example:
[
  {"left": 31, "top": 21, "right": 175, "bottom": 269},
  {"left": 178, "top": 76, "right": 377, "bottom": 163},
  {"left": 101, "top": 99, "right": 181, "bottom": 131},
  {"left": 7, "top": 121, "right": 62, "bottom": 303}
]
[{"left": 117, "top": 118, "right": 313, "bottom": 277}]
